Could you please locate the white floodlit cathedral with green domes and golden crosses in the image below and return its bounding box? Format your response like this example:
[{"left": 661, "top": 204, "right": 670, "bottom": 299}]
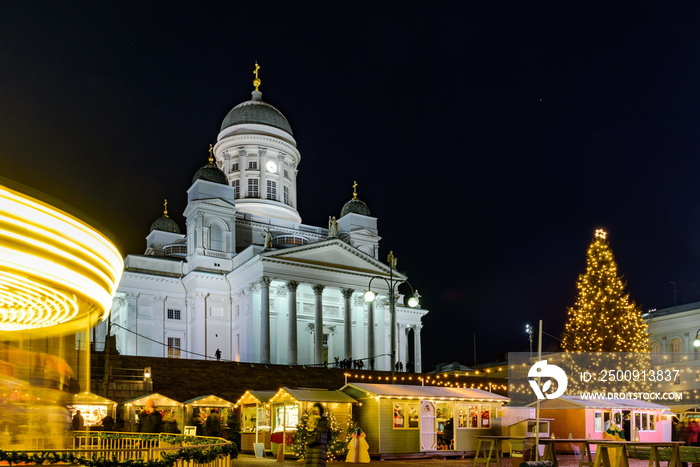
[{"left": 96, "top": 67, "right": 428, "bottom": 371}]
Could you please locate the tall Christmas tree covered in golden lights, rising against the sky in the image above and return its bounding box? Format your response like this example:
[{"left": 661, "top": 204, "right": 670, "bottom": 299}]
[{"left": 562, "top": 229, "right": 649, "bottom": 352}]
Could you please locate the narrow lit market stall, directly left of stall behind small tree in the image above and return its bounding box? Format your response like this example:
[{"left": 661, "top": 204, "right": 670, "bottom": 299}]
[{"left": 236, "top": 390, "right": 277, "bottom": 452}]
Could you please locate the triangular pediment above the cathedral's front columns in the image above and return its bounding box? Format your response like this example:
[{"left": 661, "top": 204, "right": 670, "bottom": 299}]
[{"left": 260, "top": 239, "right": 405, "bottom": 279}]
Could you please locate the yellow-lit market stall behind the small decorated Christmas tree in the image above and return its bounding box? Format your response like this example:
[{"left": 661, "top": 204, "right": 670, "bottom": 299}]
[{"left": 270, "top": 387, "right": 356, "bottom": 454}]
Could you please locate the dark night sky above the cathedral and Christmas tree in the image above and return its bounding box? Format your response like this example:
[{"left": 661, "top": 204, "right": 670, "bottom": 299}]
[{"left": 0, "top": 1, "right": 700, "bottom": 368}]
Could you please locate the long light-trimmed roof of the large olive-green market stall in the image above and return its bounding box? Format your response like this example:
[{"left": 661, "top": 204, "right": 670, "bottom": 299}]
[{"left": 341, "top": 383, "right": 510, "bottom": 403}]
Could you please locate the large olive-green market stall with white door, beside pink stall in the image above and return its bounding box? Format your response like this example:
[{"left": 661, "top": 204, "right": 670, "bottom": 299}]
[{"left": 341, "top": 383, "right": 508, "bottom": 457}]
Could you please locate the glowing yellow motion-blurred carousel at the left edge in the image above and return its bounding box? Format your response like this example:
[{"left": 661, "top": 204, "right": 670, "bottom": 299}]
[{"left": 0, "top": 180, "right": 123, "bottom": 450}]
